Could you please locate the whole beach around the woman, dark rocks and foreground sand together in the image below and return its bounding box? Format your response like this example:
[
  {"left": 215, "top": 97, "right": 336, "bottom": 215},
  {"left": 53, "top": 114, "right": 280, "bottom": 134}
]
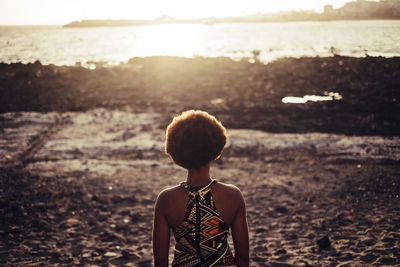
[{"left": 0, "top": 56, "right": 400, "bottom": 266}]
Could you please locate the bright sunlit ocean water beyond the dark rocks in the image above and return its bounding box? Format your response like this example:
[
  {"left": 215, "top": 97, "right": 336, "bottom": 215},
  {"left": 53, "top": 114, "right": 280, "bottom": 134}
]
[{"left": 0, "top": 20, "right": 400, "bottom": 65}]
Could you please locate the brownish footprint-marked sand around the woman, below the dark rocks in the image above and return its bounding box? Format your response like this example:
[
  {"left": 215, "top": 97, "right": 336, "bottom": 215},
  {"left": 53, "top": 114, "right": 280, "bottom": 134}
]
[{"left": 0, "top": 108, "right": 400, "bottom": 266}]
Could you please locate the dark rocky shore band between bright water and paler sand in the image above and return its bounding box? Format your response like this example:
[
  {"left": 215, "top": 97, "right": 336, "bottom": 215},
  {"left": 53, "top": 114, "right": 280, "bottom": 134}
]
[{"left": 0, "top": 56, "right": 400, "bottom": 136}]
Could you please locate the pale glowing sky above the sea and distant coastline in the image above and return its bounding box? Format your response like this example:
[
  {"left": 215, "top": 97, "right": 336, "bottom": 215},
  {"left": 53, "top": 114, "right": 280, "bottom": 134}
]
[{"left": 0, "top": 0, "right": 356, "bottom": 25}]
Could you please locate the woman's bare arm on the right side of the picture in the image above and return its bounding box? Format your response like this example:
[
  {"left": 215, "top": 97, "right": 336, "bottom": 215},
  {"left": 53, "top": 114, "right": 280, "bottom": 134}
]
[{"left": 231, "top": 190, "right": 250, "bottom": 267}]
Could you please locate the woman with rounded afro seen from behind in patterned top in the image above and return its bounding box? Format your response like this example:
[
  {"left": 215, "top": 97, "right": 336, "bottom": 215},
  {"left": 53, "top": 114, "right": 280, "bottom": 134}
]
[{"left": 153, "top": 110, "right": 249, "bottom": 267}]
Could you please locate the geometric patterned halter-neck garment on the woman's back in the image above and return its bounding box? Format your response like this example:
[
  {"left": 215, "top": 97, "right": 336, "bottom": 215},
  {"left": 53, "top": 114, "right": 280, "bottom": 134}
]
[{"left": 172, "top": 180, "right": 236, "bottom": 267}]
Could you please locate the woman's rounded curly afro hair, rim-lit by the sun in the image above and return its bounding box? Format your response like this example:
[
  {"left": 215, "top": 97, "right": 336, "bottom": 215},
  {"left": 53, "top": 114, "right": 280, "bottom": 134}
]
[{"left": 165, "top": 110, "right": 227, "bottom": 169}]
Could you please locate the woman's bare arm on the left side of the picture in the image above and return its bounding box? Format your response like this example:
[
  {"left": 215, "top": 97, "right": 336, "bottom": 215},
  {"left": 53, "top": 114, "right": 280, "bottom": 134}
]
[{"left": 153, "top": 191, "right": 170, "bottom": 267}]
